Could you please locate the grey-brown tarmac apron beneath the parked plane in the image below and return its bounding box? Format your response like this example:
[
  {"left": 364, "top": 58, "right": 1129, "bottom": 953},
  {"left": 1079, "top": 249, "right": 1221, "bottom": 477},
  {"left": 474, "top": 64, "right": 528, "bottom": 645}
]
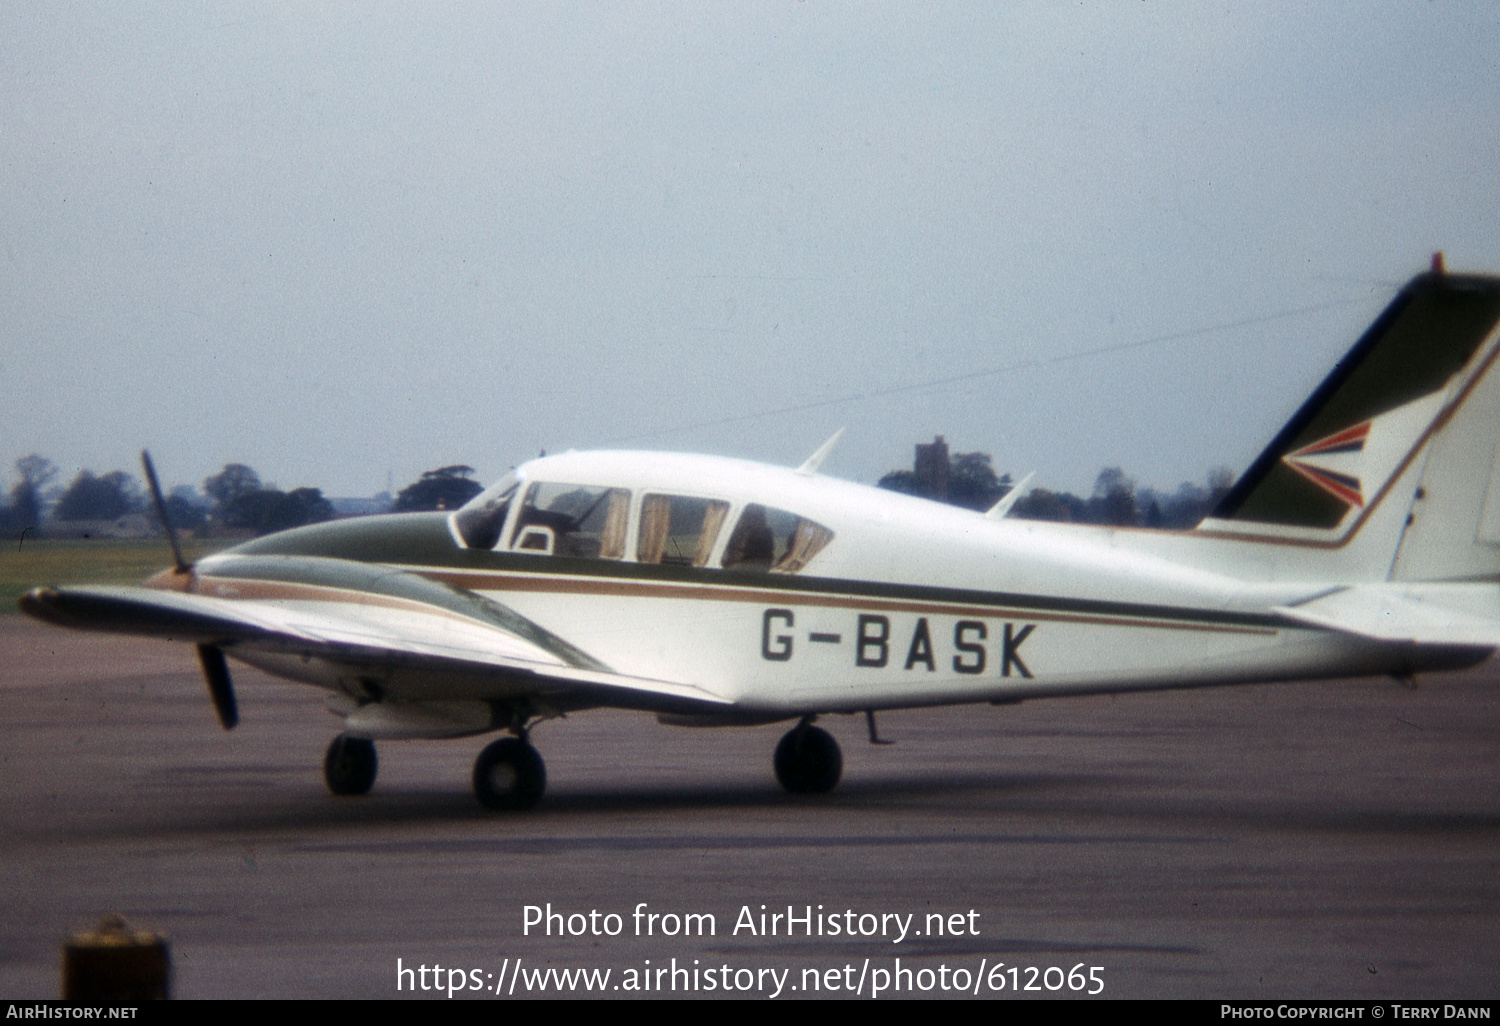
[{"left": 0, "top": 617, "right": 1500, "bottom": 999}]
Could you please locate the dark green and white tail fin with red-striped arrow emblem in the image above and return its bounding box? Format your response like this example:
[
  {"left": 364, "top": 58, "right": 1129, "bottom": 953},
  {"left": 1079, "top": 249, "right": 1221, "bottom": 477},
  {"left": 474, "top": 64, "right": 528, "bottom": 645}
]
[{"left": 1199, "top": 268, "right": 1500, "bottom": 581}]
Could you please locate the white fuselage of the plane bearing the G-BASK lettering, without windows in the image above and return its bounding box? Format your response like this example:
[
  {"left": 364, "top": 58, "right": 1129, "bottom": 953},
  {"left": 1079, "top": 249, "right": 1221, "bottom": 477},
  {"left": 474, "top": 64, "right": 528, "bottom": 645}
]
[{"left": 357, "top": 453, "right": 1434, "bottom": 713}]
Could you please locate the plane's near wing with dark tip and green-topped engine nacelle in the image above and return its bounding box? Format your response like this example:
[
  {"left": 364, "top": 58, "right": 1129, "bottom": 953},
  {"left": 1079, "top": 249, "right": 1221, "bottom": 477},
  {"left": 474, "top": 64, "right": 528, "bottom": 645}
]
[{"left": 21, "top": 558, "right": 732, "bottom": 714}]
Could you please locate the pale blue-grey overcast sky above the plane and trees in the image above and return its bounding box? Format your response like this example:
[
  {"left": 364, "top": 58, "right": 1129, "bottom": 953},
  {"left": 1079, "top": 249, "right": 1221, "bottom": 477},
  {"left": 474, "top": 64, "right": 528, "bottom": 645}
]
[{"left": 0, "top": 0, "right": 1500, "bottom": 495}]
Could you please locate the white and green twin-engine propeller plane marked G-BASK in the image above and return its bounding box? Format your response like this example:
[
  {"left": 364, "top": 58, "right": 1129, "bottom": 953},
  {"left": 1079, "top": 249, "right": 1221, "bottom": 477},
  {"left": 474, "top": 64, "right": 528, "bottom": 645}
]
[{"left": 21, "top": 261, "right": 1500, "bottom": 809}]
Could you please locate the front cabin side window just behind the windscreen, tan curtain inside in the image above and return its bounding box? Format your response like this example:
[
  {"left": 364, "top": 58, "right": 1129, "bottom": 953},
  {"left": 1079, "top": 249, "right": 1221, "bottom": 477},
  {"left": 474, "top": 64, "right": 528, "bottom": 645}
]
[{"left": 512, "top": 482, "right": 630, "bottom": 560}]
